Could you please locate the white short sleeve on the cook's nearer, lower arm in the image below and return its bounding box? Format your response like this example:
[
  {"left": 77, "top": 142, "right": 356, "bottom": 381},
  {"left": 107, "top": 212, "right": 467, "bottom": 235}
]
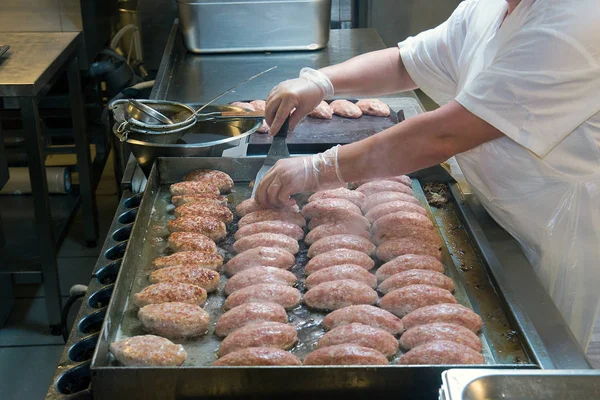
[{"left": 456, "top": 26, "right": 600, "bottom": 158}]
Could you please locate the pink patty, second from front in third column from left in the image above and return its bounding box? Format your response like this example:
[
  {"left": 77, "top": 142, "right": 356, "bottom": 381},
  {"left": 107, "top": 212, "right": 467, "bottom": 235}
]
[{"left": 317, "top": 322, "right": 398, "bottom": 357}]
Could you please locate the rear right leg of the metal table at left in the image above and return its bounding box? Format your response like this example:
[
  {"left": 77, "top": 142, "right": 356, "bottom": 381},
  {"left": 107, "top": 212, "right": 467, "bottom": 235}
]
[{"left": 68, "top": 57, "right": 98, "bottom": 247}]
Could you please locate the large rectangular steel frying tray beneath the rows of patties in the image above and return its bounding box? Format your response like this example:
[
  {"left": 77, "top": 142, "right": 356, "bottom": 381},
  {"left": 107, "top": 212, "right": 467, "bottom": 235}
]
[{"left": 91, "top": 157, "right": 536, "bottom": 399}]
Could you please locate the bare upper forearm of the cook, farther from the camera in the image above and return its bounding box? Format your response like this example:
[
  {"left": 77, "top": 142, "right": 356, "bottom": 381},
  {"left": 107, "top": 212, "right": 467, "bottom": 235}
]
[{"left": 320, "top": 47, "right": 417, "bottom": 96}]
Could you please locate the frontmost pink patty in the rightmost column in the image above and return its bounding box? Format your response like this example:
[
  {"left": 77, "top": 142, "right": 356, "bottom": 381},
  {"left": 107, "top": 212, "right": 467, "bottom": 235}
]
[{"left": 398, "top": 340, "right": 485, "bottom": 365}]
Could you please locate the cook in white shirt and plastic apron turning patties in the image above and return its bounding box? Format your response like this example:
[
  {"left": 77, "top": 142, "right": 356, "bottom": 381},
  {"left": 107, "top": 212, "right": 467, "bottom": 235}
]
[{"left": 256, "top": 0, "right": 600, "bottom": 349}]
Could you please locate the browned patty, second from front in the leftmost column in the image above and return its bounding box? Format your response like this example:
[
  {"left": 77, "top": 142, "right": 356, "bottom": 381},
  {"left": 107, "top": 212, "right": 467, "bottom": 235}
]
[{"left": 138, "top": 303, "right": 210, "bottom": 338}]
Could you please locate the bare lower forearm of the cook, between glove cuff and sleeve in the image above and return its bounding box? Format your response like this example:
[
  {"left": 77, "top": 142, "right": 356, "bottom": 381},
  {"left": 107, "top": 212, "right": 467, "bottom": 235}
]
[{"left": 338, "top": 101, "right": 503, "bottom": 182}]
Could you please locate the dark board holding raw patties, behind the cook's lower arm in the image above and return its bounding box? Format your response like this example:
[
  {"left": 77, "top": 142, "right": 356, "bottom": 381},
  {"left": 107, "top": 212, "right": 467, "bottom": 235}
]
[{"left": 248, "top": 100, "right": 404, "bottom": 154}]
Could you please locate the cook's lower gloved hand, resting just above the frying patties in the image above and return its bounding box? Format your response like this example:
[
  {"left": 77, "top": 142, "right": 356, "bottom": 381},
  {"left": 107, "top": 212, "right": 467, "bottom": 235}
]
[{"left": 255, "top": 145, "right": 345, "bottom": 208}]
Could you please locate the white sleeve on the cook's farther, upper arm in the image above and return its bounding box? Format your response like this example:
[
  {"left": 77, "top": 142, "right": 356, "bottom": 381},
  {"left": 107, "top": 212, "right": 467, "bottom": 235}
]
[{"left": 398, "top": 0, "right": 475, "bottom": 104}]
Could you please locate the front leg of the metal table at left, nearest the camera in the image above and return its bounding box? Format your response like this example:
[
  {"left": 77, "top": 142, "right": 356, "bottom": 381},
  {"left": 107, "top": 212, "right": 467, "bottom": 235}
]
[{"left": 14, "top": 97, "right": 61, "bottom": 335}]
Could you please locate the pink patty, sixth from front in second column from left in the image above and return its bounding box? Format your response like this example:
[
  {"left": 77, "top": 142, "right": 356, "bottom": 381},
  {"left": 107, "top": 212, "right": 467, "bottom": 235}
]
[{"left": 225, "top": 247, "right": 296, "bottom": 275}]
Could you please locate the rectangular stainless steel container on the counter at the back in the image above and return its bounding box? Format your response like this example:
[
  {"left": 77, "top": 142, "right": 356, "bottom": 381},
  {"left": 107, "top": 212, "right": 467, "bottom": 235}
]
[{"left": 177, "top": 0, "right": 331, "bottom": 53}]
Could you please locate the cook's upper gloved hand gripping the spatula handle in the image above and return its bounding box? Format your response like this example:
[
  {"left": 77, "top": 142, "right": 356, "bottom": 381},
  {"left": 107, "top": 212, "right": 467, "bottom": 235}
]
[{"left": 265, "top": 68, "right": 334, "bottom": 136}]
